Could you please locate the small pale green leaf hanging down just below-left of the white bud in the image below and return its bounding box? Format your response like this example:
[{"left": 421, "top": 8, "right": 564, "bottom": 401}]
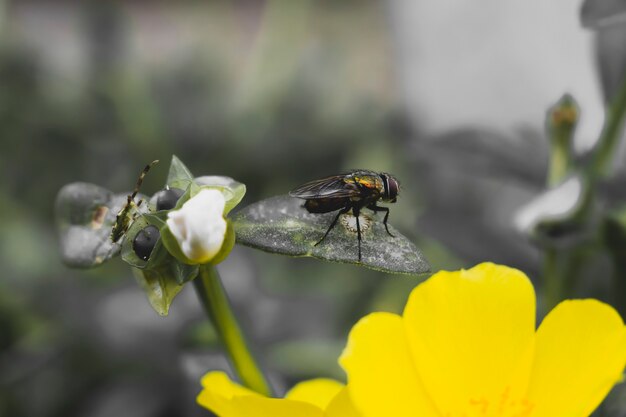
[{"left": 133, "top": 262, "right": 198, "bottom": 316}]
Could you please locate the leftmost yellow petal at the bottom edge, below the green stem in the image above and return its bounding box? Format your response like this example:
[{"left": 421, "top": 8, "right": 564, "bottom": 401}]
[{"left": 197, "top": 372, "right": 324, "bottom": 417}]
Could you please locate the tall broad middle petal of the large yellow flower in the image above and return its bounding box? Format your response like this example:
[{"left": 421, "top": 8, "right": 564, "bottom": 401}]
[{"left": 402, "top": 263, "right": 535, "bottom": 416}]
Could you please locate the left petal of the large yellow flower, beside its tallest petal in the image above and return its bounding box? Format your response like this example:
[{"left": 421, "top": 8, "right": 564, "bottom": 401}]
[{"left": 339, "top": 313, "right": 437, "bottom": 417}]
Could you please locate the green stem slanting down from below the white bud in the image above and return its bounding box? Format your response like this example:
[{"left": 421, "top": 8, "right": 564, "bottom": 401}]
[{"left": 194, "top": 265, "right": 272, "bottom": 397}]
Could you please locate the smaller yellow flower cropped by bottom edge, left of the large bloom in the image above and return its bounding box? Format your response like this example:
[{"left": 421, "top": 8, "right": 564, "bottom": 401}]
[{"left": 198, "top": 371, "right": 360, "bottom": 417}]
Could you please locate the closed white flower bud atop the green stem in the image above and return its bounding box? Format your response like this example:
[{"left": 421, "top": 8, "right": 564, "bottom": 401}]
[{"left": 167, "top": 189, "right": 226, "bottom": 263}]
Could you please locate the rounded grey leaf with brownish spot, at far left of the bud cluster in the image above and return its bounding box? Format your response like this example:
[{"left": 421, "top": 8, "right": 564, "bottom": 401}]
[{"left": 55, "top": 182, "right": 147, "bottom": 268}]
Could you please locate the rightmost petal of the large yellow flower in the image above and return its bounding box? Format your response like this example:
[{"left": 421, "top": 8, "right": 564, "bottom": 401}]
[{"left": 528, "top": 300, "right": 626, "bottom": 417}]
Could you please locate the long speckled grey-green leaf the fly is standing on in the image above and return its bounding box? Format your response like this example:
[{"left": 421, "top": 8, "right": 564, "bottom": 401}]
[{"left": 233, "top": 195, "right": 430, "bottom": 274}]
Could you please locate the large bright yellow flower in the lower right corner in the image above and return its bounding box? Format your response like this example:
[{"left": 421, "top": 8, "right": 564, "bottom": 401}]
[{"left": 340, "top": 264, "right": 626, "bottom": 417}]
